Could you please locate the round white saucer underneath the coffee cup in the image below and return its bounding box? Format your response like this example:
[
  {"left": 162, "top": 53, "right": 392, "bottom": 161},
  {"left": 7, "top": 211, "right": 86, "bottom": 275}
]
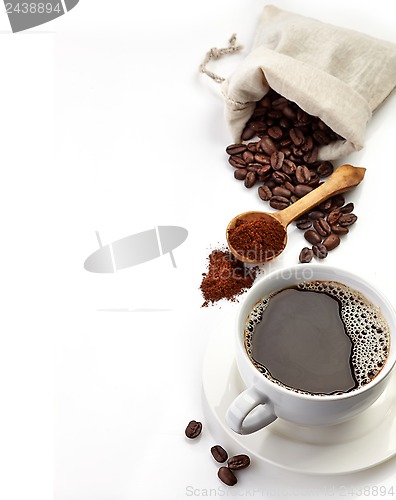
[{"left": 203, "top": 318, "right": 396, "bottom": 474}]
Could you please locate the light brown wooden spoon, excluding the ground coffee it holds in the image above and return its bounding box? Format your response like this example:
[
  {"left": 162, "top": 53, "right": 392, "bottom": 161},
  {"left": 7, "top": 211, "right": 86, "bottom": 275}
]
[{"left": 226, "top": 165, "right": 366, "bottom": 264}]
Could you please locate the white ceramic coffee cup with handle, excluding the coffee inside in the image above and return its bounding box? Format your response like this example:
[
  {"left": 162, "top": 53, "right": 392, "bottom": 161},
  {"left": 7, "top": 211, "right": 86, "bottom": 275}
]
[{"left": 226, "top": 264, "right": 396, "bottom": 434}]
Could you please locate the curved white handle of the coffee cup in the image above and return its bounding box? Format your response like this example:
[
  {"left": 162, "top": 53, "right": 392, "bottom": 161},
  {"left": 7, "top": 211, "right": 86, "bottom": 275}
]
[{"left": 226, "top": 386, "right": 277, "bottom": 435}]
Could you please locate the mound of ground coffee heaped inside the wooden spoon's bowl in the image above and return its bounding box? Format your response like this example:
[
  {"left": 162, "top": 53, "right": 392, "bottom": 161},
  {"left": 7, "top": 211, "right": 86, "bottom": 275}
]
[{"left": 228, "top": 217, "right": 285, "bottom": 261}]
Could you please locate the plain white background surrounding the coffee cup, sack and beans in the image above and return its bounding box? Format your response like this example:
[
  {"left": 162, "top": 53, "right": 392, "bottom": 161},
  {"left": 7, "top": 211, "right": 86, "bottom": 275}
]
[{"left": 0, "top": 0, "right": 396, "bottom": 500}]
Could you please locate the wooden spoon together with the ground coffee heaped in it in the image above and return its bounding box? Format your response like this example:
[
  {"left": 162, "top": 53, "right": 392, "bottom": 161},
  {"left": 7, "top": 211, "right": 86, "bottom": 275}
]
[{"left": 226, "top": 164, "right": 366, "bottom": 265}]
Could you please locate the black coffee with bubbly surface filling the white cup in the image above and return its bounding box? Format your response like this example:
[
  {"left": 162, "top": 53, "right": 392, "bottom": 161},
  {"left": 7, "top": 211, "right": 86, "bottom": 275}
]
[{"left": 245, "top": 281, "right": 390, "bottom": 394}]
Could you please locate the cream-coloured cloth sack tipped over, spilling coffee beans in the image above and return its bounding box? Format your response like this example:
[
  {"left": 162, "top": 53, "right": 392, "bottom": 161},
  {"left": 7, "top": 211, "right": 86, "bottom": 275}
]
[{"left": 213, "top": 5, "right": 396, "bottom": 160}]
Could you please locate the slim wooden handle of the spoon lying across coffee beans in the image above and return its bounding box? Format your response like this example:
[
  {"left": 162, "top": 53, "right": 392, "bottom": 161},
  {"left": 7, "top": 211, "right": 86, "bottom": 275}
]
[{"left": 272, "top": 164, "right": 366, "bottom": 227}]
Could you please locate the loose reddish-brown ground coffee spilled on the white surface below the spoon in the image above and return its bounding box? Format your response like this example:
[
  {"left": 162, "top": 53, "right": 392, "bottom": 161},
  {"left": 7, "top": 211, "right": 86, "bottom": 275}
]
[{"left": 200, "top": 249, "right": 257, "bottom": 307}]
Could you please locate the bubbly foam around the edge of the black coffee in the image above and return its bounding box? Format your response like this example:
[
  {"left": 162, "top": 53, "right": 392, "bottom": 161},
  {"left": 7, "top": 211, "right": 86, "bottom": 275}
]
[{"left": 245, "top": 281, "right": 390, "bottom": 394}]
